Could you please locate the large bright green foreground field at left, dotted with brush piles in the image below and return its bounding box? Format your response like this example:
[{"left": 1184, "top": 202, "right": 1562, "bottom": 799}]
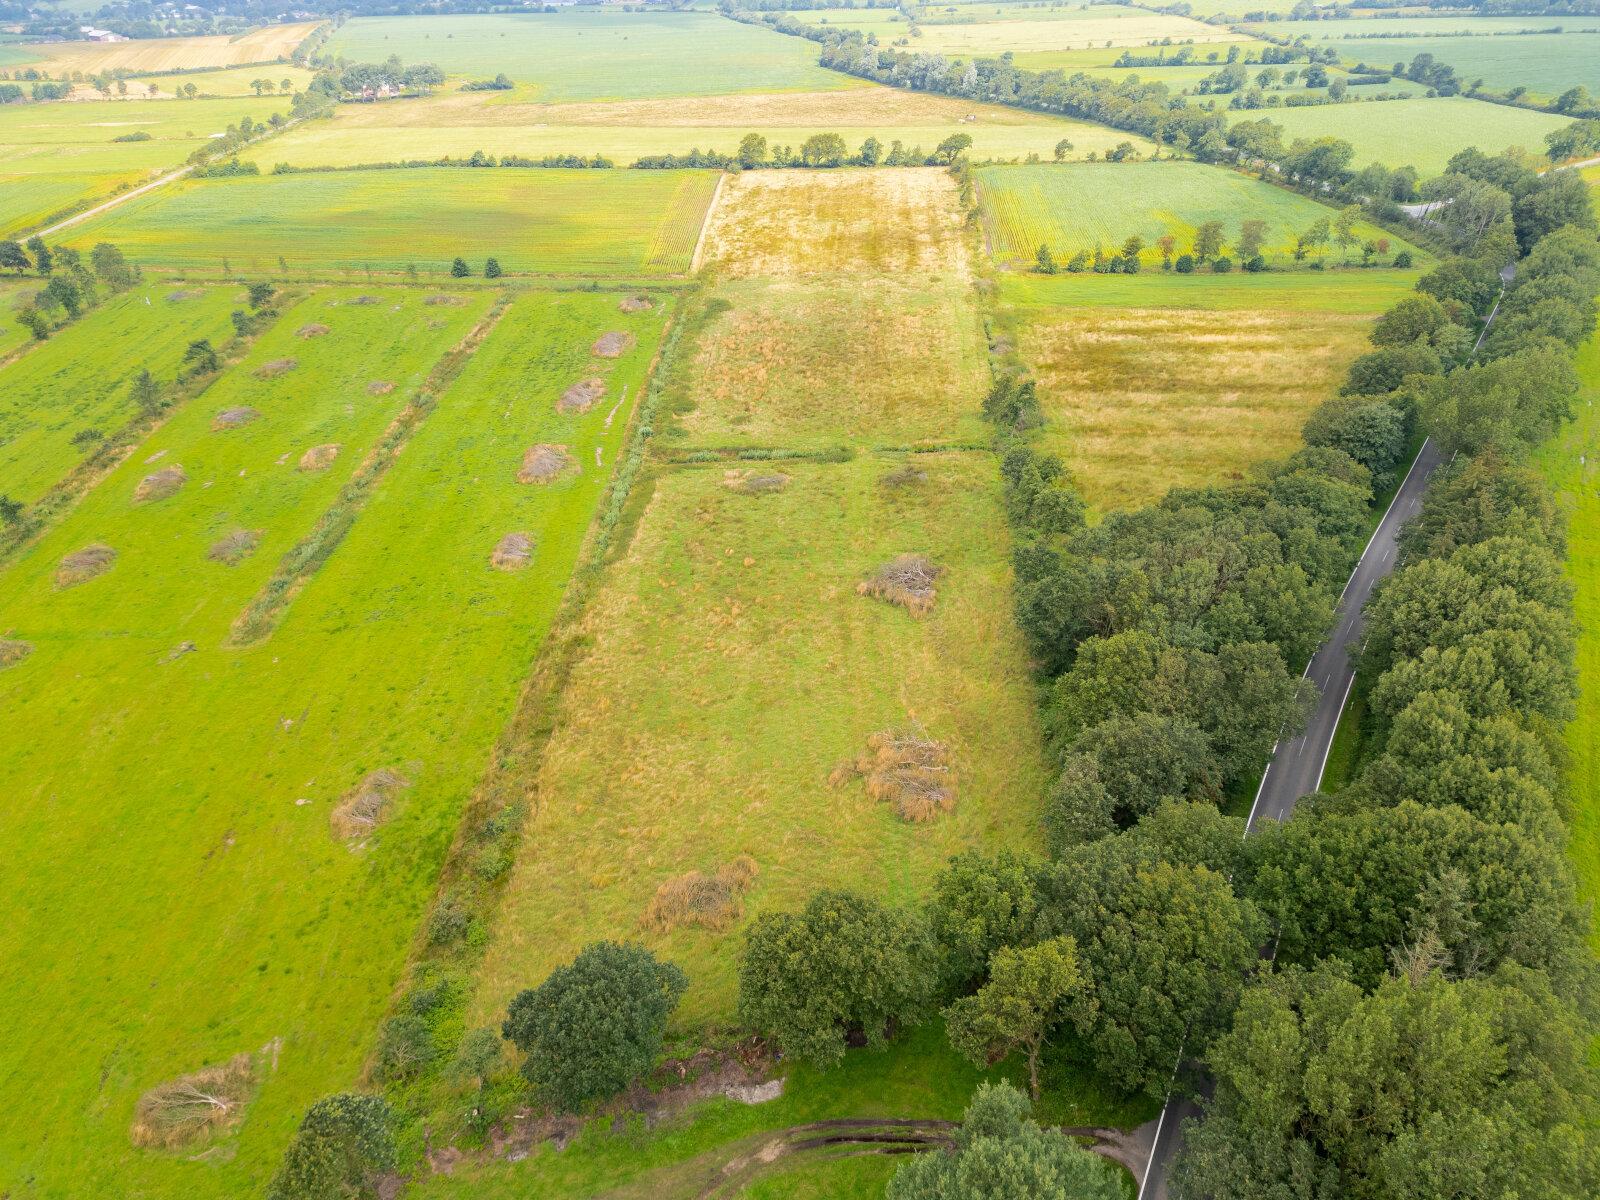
[{"left": 0, "top": 288, "right": 666, "bottom": 1197}]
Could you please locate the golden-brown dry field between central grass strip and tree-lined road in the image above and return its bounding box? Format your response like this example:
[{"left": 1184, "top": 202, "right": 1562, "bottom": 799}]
[{"left": 1019, "top": 309, "right": 1371, "bottom": 510}]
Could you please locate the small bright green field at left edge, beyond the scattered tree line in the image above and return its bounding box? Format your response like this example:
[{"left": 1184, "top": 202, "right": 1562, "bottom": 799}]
[{"left": 0, "top": 285, "right": 242, "bottom": 504}]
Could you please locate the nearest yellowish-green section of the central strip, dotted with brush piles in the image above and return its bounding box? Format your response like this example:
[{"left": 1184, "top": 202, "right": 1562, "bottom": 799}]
[{"left": 472, "top": 453, "right": 1048, "bottom": 1026}]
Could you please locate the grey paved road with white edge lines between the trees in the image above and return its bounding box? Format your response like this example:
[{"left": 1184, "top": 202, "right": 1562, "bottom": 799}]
[{"left": 1139, "top": 442, "right": 1440, "bottom": 1200}]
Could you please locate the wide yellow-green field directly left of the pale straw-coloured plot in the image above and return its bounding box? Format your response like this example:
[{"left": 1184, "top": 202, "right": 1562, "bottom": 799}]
[{"left": 59, "top": 168, "right": 717, "bottom": 275}]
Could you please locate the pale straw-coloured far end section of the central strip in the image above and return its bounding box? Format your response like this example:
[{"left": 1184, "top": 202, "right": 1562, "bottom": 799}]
[{"left": 706, "top": 166, "right": 968, "bottom": 278}]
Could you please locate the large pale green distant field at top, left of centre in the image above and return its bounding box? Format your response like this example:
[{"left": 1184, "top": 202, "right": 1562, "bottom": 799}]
[{"left": 323, "top": 8, "right": 861, "bottom": 102}]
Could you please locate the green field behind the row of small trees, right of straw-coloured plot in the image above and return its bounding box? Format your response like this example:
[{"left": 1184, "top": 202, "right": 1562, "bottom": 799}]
[{"left": 978, "top": 162, "right": 1405, "bottom": 264}]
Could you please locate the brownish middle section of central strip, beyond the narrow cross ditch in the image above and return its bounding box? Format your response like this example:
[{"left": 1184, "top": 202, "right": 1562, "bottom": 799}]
[{"left": 662, "top": 274, "right": 987, "bottom": 450}]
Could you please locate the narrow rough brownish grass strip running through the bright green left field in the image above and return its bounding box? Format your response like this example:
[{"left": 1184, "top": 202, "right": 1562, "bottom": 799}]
[{"left": 222, "top": 298, "right": 510, "bottom": 646}]
